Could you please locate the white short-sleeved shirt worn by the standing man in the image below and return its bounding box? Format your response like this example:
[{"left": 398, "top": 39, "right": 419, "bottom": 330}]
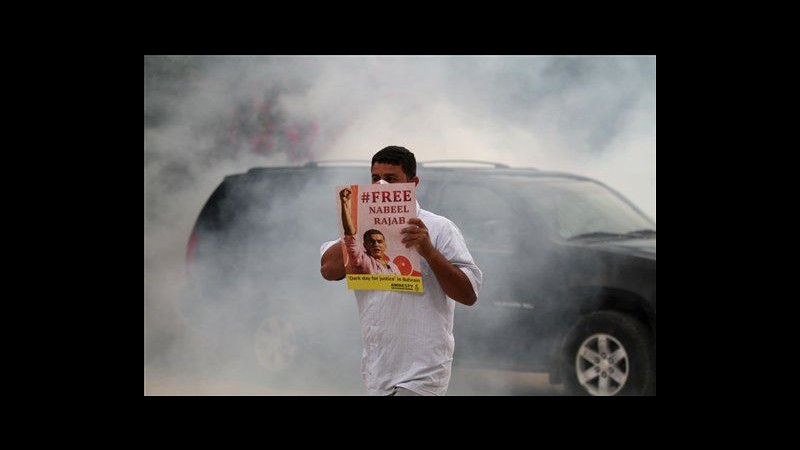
[{"left": 320, "top": 203, "right": 483, "bottom": 395}]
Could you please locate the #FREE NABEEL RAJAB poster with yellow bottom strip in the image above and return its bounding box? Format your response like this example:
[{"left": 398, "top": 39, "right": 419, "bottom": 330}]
[{"left": 336, "top": 183, "right": 423, "bottom": 293}]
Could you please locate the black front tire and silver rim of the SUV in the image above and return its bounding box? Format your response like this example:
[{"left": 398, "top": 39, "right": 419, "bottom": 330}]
[{"left": 562, "top": 311, "right": 656, "bottom": 396}]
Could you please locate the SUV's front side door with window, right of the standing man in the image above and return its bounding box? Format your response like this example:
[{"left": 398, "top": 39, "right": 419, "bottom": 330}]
[{"left": 424, "top": 176, "right": 533, "bottom": 368}]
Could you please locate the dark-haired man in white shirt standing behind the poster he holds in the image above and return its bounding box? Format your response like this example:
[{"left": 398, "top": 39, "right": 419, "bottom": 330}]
[{"left": 320, "top": 146, "right": 483, "bottom": 395}]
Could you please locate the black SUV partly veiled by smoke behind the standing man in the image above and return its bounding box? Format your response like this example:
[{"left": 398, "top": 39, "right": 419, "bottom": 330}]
[{"left": 185, "top": 162, "right": 656, "bottom": 395}]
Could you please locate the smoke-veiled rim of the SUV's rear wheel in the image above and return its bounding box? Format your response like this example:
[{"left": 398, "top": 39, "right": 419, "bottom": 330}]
[{"left": 254, "top": 317, "right": 297, "bottom": 372}]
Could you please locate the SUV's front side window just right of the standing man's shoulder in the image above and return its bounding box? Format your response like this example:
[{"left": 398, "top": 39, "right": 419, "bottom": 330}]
[{"left": 434, "top": 182, "right": 520, "bottom": 253}]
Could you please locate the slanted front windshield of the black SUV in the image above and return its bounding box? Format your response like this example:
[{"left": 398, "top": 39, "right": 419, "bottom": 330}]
[{"left": 523, "top": 179, "right": 656, "bottom": 240}]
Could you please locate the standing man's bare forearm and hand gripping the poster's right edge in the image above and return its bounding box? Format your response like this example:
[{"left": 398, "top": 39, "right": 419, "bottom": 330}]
[{"left": 400, "top": 217, "right": 478, "bottom": 306}]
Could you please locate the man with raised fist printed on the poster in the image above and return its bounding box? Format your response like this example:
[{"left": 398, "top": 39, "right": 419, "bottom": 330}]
[{"left": 339, "top": 188, "right": 400, "bottom": 275}]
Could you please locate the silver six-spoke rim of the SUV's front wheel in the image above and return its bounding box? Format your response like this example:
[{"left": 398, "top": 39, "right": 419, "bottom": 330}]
[{"left": 575, "top": 333, "right": 630, "bottom": 395}]
